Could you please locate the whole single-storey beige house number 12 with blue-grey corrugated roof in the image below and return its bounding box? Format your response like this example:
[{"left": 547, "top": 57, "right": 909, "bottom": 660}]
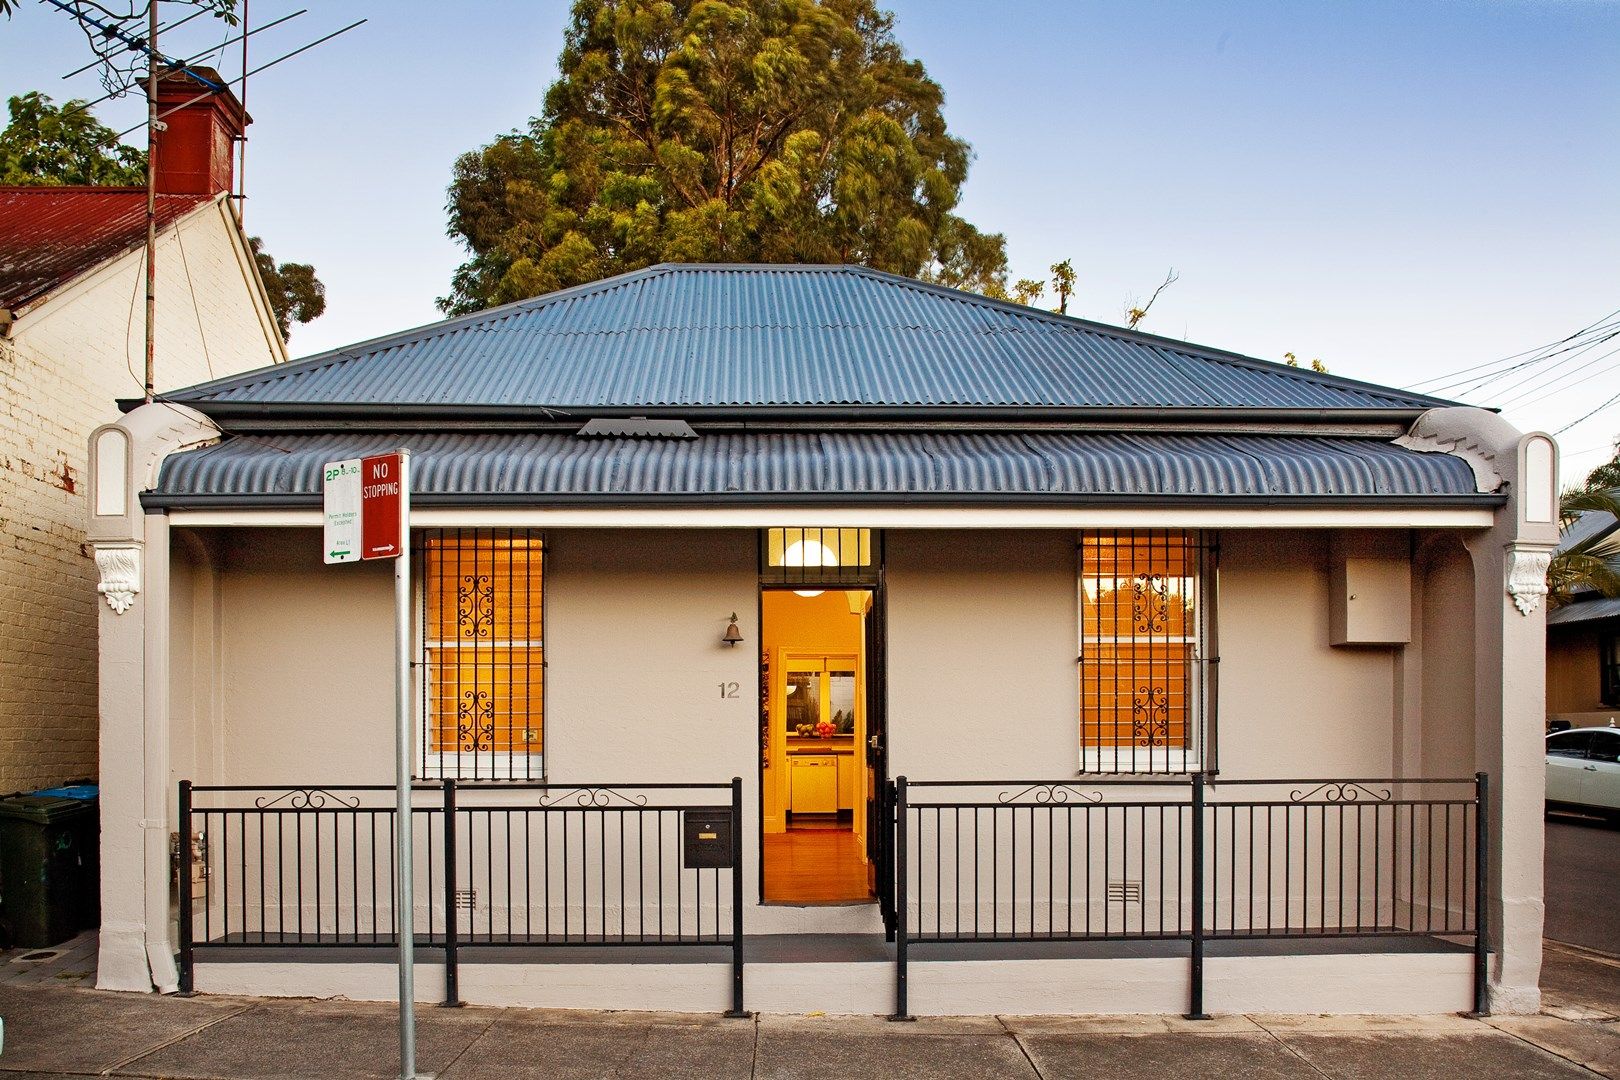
[{"left": 91, "top": 266, "right": 1557, "bottom": 1015}]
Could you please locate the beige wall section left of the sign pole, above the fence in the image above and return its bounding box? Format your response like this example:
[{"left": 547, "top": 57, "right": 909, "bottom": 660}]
[{"left": 170, "top": 529, "right": 394, "bottom": 784}]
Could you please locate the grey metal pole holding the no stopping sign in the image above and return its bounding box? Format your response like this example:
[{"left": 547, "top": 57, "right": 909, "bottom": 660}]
[{"left": 394, "top": 450, "right": 414, "bottom": 1080}]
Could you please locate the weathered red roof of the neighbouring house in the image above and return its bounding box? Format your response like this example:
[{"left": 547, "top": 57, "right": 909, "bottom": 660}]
[{"left": 0, "top": 186, "right": 212, "bottom": 309}]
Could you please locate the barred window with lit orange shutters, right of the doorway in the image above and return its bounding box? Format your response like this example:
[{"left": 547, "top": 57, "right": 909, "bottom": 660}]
[{"left": 1079, "top": 529, "right": 1213, "bottom": 772}]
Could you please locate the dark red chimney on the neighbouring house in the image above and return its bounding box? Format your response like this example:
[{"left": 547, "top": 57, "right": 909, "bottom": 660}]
[{"left": 156, "top": 68, "right": 253, "bottom": 194}]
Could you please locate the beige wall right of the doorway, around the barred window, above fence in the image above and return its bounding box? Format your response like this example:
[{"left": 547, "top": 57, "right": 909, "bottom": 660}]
[{"left": 886, "top": 531, "right": 1395, "bottom": 779}]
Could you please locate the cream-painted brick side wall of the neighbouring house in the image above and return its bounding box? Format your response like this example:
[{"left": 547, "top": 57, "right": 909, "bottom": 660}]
[{"left": 0, "top": 207, "right": 280, "bottom": 793}]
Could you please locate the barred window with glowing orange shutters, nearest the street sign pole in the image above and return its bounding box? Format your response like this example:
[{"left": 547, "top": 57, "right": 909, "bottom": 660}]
[{"left": 418, "top": 529, "right": 546, "bottom": 780}]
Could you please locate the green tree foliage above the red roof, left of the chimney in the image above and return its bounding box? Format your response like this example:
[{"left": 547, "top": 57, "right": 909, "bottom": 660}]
[{"left": 0, "top": 91, "right": 146, "bottom": 186}]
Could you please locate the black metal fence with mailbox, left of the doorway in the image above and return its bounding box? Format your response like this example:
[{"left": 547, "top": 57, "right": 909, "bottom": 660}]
[{"left": 178, "top": 779, "right": 744, "bottom": 1014}]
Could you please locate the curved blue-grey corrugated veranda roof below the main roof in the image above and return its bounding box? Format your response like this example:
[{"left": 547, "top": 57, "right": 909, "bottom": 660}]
[{"left": 151, "top": 432, "right": 1476, "bottom": 505}]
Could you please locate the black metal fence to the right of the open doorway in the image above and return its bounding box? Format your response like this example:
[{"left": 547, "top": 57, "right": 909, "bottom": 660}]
[{"left": 893, "top": 774, "right": 1489, "bottom": 1017}]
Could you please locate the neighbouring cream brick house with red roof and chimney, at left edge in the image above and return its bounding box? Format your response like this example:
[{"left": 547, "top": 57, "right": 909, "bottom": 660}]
[{"left": 0, "top": 74, "right": 287, "bottom": 792}]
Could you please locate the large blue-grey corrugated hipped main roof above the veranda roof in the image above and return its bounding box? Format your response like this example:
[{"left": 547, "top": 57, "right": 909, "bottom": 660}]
[{"left": 168, "top": 266, "right": 1445, "bottom": 419}]
